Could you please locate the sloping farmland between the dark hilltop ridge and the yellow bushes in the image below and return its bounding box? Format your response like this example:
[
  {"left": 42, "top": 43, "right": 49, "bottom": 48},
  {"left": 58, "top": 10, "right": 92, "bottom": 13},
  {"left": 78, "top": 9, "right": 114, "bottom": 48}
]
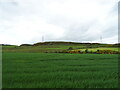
[{"left": 3, "top": 42, "right": 119, "bottom": 53}]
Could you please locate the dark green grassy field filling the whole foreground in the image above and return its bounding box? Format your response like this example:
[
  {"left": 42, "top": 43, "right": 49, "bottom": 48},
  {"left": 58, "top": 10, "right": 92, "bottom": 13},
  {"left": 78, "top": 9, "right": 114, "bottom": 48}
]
[{"left": 3, "top": 52, "right": 118, "bottom": 88}]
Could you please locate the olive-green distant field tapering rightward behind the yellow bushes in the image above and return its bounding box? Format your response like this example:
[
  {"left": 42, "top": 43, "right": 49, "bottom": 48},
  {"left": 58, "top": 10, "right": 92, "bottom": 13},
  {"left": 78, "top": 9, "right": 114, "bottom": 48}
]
[{"left": 3, "top": 45, "right": 85, "bottom": 53}]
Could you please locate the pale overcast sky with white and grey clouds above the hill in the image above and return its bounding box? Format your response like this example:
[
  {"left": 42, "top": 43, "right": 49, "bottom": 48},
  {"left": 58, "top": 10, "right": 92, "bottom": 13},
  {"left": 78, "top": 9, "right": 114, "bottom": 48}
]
[{"left": 0, "top": 0, "right": 119, "bottom": 45}]
